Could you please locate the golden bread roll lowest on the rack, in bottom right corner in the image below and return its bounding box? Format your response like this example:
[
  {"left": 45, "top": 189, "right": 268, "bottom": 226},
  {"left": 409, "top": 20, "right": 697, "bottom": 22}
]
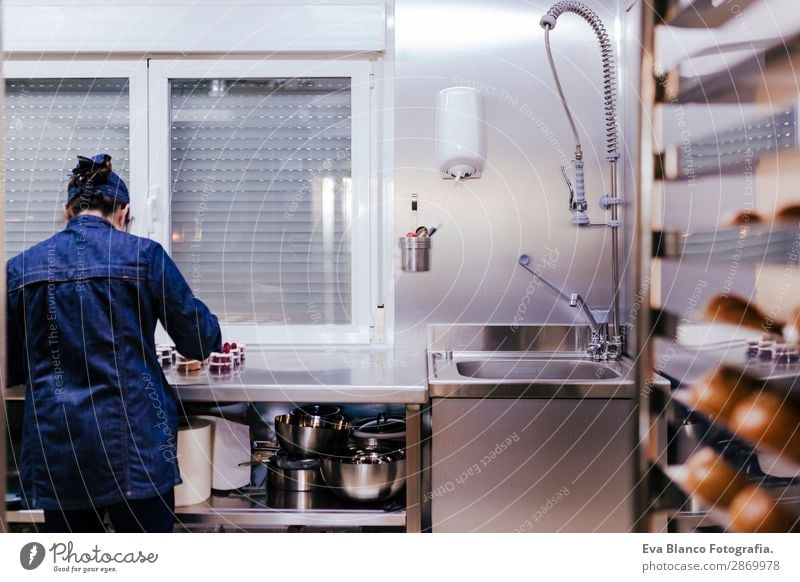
[{"left": 728, "top": 485, "right": 797, "bottom": 533}]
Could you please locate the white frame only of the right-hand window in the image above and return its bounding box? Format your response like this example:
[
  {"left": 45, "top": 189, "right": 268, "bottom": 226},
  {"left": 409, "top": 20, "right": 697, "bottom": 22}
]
[{"left": 148, "top": 58, "right": 377, "bottom": 346}]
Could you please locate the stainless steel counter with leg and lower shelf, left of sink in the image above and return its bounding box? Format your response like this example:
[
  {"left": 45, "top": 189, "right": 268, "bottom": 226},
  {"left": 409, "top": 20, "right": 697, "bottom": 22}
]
[{"left": 5, "top": 347, "right": 428, "bottom": 532}]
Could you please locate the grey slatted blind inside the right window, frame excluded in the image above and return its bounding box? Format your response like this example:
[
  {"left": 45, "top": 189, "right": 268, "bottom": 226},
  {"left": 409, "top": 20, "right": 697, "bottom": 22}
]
[{"left": 170, "top": 78, "right": 353, "bottom": 325}]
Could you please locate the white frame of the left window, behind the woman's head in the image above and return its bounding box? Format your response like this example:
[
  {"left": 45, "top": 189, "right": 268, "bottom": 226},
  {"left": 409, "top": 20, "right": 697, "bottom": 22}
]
[{"left": 3, "top": 58, "right": 148, "bottom": 241}]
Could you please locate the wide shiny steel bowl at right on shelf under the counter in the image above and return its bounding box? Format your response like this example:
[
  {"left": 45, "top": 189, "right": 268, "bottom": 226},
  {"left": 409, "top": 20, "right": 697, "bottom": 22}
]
[{"left": 321, "top": 445, "right": 406, "bottom": 501}]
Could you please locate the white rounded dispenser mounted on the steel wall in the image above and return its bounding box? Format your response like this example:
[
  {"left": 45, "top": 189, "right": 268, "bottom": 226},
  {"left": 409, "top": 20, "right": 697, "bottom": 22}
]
[{"left": 436, "top": 87, "right": 486, "bottom": 180}]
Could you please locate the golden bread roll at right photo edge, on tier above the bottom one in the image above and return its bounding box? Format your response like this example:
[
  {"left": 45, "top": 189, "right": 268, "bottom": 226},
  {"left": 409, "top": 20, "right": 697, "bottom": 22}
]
[{"left": 729, "top": 392, "right": 800, "bottom": 461}]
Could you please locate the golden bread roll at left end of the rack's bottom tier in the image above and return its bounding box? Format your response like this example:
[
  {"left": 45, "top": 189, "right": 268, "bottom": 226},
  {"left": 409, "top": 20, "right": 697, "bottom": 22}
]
[{"left": 682, "top": 448, "right": 746, "bottom": 507}]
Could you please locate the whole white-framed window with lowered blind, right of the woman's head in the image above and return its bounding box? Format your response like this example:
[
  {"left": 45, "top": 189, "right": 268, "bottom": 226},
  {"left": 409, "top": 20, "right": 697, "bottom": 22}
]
[{"left": 151, "top": 61, "right": 370, "bottom": 343}]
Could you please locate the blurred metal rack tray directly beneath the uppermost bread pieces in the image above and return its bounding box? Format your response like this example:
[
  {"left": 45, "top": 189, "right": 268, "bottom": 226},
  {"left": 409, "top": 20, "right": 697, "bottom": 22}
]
[{"left": 652, "top": 226, "right": 800, "bottom": 265}]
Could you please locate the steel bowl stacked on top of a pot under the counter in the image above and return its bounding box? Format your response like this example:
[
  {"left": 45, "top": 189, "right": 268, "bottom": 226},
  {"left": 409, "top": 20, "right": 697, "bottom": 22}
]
[{"left": 275, "top": 414, "right": 350, "bottom": 459}]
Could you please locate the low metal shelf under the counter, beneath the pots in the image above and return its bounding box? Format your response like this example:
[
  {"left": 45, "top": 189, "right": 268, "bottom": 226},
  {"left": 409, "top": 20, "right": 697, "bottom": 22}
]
[{"left": 6, "top": 492, "right": 406, "bottom": 530}]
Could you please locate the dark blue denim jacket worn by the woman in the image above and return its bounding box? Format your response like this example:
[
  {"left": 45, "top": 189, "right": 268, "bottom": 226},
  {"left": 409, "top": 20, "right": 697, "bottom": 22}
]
[{"left": 6, "top": 214, "right": 221, "bottom": 510}]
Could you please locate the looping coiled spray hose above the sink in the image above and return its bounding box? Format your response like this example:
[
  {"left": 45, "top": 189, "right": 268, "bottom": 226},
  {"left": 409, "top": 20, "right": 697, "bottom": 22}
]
[{"left": 539, "top": 0, "right": 619, "bottom": 160}]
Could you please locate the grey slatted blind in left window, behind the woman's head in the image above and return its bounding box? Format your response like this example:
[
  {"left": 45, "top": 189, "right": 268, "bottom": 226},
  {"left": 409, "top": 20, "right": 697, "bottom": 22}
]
[{"left": 3, "top": 79, "right": 130, "bottom": 258}]
